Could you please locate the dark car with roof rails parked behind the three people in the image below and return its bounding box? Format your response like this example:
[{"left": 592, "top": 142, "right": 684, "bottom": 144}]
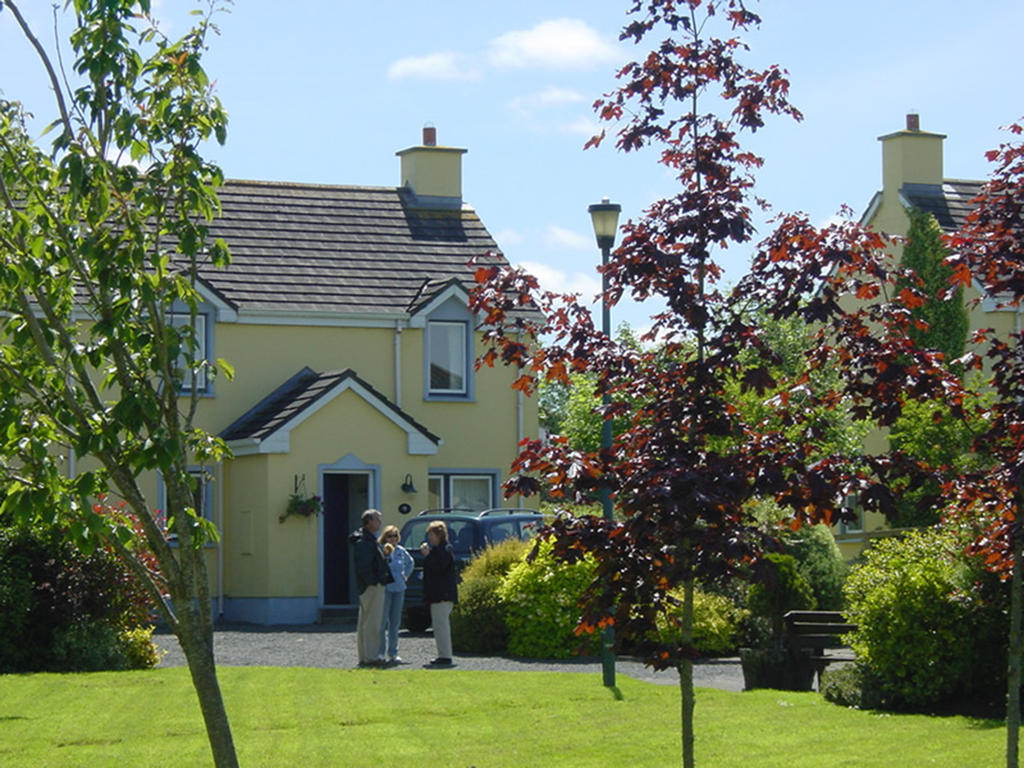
[{"left": 401, "top": 508, "right": 544, "bottom": 632}]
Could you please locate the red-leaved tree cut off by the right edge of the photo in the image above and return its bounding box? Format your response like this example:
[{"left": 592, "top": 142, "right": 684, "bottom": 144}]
[{"left": 945, "top": 120, "right": 1024, "bottom": 768}]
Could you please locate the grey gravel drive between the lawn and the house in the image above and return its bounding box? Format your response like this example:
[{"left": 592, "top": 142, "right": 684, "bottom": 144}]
[{"left": 154, "top": 625, "right": 743, "bottom": 691}]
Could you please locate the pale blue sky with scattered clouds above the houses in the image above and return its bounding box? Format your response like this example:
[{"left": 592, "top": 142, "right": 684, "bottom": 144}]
[{"left": 0, "top": 0, "right": 1024, "bottom": 328}]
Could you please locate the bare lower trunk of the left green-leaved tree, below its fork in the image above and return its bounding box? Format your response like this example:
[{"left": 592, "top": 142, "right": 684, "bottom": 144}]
[{"left": 176, "top": 610, "right": 239, "bottom": 768}]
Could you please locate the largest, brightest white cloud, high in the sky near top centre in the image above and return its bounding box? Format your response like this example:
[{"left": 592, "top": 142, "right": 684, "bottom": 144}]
[{"left": 489, "top": 18, "right": 622, "bottom": 70}]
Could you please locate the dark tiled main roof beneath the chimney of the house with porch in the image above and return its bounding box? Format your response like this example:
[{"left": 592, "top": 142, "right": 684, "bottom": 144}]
[{"left": 193, "top": 180, "right": 503, "bottom": 314}]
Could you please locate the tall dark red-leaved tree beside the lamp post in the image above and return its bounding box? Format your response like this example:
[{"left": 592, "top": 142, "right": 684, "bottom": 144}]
[{"left": 472, "top": 0, "right": 961, "bottom": 766}]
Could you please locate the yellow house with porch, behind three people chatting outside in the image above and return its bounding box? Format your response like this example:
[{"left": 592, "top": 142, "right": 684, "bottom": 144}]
[{"left": 173, "top": 128, "right": 538, "bottom": 624}]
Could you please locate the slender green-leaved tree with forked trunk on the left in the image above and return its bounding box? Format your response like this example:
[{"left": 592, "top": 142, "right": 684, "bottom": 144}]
[{"left": 0, "top": 0, "right": 238, "bottom": 766}]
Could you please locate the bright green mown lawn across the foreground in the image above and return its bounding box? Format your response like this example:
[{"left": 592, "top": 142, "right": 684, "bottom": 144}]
[{"left": 0, "top": 667, "right": 1005, "bottom": 768}]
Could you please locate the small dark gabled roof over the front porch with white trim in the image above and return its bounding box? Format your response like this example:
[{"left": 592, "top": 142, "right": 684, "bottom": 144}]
[{"left": 220, "top": 368, "right": 440, "bottom": 443}]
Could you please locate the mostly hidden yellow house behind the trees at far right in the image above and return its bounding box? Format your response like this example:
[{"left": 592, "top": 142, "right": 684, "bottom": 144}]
[{"left": 837, "top": 114, "right": 1007, "bottom": 557}]
